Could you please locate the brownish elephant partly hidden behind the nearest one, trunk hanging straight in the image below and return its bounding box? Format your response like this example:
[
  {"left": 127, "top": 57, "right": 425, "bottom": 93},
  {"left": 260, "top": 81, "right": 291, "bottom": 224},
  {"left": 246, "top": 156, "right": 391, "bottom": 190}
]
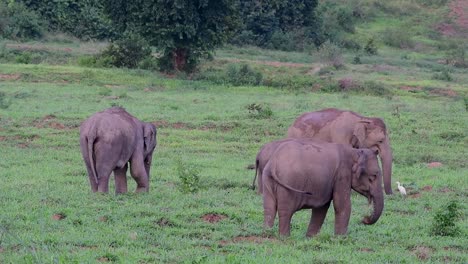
[{"left": 288, "top": 108, "right": 393, "bottom": 195}]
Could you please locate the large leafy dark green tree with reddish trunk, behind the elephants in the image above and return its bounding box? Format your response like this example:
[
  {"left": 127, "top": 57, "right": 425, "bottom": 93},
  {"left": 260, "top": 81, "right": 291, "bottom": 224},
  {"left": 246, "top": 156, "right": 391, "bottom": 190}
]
[{"left": 104, "top": 0, "right": 237, "bottom": 71}]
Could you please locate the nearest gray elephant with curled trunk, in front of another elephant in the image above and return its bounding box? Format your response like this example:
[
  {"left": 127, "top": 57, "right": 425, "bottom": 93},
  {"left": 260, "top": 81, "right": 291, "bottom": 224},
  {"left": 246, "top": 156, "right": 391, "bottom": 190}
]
[{"left": 262, "top": 139, "right": 384, "bottom": 236}]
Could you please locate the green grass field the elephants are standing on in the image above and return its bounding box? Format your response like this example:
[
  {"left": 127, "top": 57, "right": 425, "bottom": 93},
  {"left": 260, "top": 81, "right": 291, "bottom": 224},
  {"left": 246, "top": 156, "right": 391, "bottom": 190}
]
[{"left": 0, "top": 55, "right": 468, "bottom": 263}]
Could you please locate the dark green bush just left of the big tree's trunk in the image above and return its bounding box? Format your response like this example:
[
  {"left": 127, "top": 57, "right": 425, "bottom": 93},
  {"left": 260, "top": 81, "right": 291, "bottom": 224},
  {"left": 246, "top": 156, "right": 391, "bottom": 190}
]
[{"left": 95, "top": 33, "right": 151, "bottom": 68}]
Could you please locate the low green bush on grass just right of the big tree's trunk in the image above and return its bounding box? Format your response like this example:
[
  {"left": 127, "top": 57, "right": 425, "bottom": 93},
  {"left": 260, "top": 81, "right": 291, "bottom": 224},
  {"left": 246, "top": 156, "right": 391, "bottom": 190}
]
[{"left": 226, "top": 64, "right": 263, "bottom": 86}]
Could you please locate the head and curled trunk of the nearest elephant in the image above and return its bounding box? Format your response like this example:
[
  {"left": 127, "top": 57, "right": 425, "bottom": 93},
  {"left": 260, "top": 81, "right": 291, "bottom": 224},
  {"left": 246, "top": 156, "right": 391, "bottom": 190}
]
[{"left": 351, "top": 149, "right": 384, "bottom": 225}]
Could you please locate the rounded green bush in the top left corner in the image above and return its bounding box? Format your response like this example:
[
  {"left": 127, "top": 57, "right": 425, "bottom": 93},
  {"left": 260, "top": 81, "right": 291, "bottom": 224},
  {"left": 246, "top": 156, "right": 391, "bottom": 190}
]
[{"left": 0, "top": 1, "right": 44, "bottom": 39}]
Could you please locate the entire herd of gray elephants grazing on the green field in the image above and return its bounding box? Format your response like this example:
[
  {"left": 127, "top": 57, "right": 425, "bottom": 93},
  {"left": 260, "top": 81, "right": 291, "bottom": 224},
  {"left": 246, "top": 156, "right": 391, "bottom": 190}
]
[{"left": 80, "top": 107, "right": 393, "bottom": 236}]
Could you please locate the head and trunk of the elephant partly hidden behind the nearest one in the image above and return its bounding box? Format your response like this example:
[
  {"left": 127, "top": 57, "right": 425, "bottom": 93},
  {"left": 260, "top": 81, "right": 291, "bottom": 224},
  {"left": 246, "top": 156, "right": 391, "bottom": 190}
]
[{"left": 351, "top": 118, "right": 393, "bottom": 194}]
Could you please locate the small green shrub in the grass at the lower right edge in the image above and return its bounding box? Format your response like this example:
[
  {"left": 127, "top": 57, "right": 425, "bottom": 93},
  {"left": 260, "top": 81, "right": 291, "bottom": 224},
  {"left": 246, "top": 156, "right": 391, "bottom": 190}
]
[{"left": 431, "top": 200, "right": 461, "bottom": 236}]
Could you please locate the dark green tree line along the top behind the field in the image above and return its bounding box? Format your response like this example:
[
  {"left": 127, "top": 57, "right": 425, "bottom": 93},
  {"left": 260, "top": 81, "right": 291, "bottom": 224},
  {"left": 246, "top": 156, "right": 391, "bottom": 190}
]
[{"left": 0, "top": 0, "right": 358, "bottom": 71}]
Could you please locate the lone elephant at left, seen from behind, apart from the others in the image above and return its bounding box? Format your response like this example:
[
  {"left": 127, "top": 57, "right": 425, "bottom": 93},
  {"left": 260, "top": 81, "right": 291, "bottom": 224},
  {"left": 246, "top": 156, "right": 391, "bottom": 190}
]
[{"left": 80, "top": 107, "right": 156, "bottom": 193}]
